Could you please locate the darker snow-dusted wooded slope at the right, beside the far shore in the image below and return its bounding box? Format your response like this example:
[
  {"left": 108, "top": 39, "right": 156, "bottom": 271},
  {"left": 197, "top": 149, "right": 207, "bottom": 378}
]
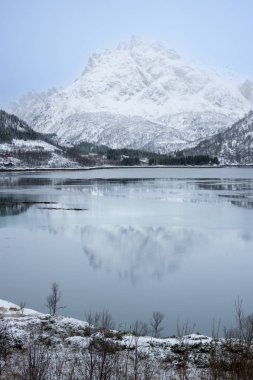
[{"left": 185, "top": 111, "right": 253, "bottom": 164}]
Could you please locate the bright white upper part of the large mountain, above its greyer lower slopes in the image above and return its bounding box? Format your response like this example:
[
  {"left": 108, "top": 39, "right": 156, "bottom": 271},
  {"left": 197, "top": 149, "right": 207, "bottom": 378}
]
[{"left": 73, "top": 37, "right": 251, "bottom": 120}]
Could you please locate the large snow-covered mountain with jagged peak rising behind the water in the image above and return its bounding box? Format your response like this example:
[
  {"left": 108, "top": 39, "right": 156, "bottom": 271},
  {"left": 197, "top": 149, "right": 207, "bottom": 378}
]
[{"left": 7, "top": 38, "right": 253, "bottom": 152}]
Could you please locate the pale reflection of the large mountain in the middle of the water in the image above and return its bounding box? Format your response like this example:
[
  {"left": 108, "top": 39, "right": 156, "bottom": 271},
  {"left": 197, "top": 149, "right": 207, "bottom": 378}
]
[{"left": 80, "top": 226, "right": 206, "bottom": 283}]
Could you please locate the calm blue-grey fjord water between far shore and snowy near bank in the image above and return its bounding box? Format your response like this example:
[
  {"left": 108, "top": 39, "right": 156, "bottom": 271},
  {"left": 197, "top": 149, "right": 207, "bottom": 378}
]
[{"left": 0, "top": 168, "right": 253, "bottom": 334}]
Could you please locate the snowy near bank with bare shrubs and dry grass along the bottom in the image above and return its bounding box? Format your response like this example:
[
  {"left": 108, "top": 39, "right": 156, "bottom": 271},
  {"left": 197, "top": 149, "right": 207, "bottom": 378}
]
[{"left": 0, "top": 300, "right": 250, "bottom": 380}]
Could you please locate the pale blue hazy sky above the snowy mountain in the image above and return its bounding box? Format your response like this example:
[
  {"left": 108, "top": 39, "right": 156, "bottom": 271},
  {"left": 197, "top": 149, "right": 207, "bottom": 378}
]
[{"left": 0, "top": 0, "right": 253, "bottom": 107}]
